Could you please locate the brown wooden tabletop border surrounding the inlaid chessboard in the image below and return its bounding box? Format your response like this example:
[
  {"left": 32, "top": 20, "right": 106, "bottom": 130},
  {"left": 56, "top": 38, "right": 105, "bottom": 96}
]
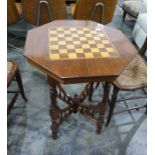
[{"left": 24, "top": 20, "right": 137, "bottom": 83}]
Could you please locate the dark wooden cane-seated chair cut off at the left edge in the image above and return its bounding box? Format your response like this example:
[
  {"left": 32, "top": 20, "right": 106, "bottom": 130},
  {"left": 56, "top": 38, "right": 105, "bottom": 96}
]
[{"left": 7, "top": 61, "right": 27, "bottom": 114}]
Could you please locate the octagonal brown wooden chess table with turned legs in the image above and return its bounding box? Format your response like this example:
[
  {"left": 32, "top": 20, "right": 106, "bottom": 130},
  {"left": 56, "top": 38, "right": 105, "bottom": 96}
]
[{"left": 24, "top": 20, "right": 137, "bottom": 139}]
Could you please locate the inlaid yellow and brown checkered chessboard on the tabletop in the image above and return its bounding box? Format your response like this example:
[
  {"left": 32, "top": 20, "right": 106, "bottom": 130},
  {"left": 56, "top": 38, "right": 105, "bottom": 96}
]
[{"left": 48, "top": 27, "right": 119, "bottom": 60}]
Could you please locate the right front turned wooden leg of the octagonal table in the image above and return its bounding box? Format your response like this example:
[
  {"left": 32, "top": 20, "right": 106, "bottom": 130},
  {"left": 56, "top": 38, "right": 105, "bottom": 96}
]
[{"left": 96, "top": 82, "right": 110, "bottom": 134}]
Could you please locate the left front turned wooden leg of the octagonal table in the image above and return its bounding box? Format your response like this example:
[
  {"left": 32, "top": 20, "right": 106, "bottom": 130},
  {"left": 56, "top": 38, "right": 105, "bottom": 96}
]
[{"left": 48, "top": 77, "right": 58, "bottom": 139}]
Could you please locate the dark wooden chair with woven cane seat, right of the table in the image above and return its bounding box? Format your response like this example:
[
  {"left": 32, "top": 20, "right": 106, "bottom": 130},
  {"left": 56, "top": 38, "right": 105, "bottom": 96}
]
[{"left": 106, "top": 38, "right": 147, "bottom": 126}]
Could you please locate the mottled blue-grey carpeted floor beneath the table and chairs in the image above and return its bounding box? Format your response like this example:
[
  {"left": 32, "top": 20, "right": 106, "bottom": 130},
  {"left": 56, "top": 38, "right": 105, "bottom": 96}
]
[{"left": 8, "top": 3, "right": 147, "bottom": 155}]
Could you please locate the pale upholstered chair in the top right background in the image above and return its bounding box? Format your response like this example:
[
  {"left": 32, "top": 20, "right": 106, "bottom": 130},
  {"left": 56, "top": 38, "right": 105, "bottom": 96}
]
[{"left": 122, "top": 0, "right": 143, "bottom": 21}]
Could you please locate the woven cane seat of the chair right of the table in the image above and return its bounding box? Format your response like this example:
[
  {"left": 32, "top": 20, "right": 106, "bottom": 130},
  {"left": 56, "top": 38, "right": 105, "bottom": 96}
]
[{"left": 114, "top": 55, "right": 147, "bottom": 90}]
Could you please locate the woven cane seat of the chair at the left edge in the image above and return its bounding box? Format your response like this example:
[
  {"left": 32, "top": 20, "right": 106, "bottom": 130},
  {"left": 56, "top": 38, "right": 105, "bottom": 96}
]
[{"left": 7, "top": 61, "right": 17, "bottom": 85}]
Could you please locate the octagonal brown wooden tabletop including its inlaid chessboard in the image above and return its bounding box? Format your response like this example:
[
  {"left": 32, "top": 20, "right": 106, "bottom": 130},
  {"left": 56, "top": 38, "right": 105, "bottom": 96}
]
[{"left": 24, "top": 20, "right": 137, "bottom": 83}]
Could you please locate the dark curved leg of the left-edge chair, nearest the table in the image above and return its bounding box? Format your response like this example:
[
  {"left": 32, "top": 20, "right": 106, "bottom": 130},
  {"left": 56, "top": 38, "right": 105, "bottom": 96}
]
[{"left": 16, "top": 69, "right": 28, "bottom": 101}]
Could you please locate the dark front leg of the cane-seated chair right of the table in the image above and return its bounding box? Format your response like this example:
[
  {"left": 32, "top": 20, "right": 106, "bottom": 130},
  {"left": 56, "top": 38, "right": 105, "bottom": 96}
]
[{"left": 106, "top": 86, "right": 119, "bottom": 126}]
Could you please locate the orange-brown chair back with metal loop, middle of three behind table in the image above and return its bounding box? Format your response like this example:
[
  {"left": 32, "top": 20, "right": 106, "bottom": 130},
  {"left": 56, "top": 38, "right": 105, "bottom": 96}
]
[{"left": 22, "top": 0, "right": 66, "bottom": 25}]
